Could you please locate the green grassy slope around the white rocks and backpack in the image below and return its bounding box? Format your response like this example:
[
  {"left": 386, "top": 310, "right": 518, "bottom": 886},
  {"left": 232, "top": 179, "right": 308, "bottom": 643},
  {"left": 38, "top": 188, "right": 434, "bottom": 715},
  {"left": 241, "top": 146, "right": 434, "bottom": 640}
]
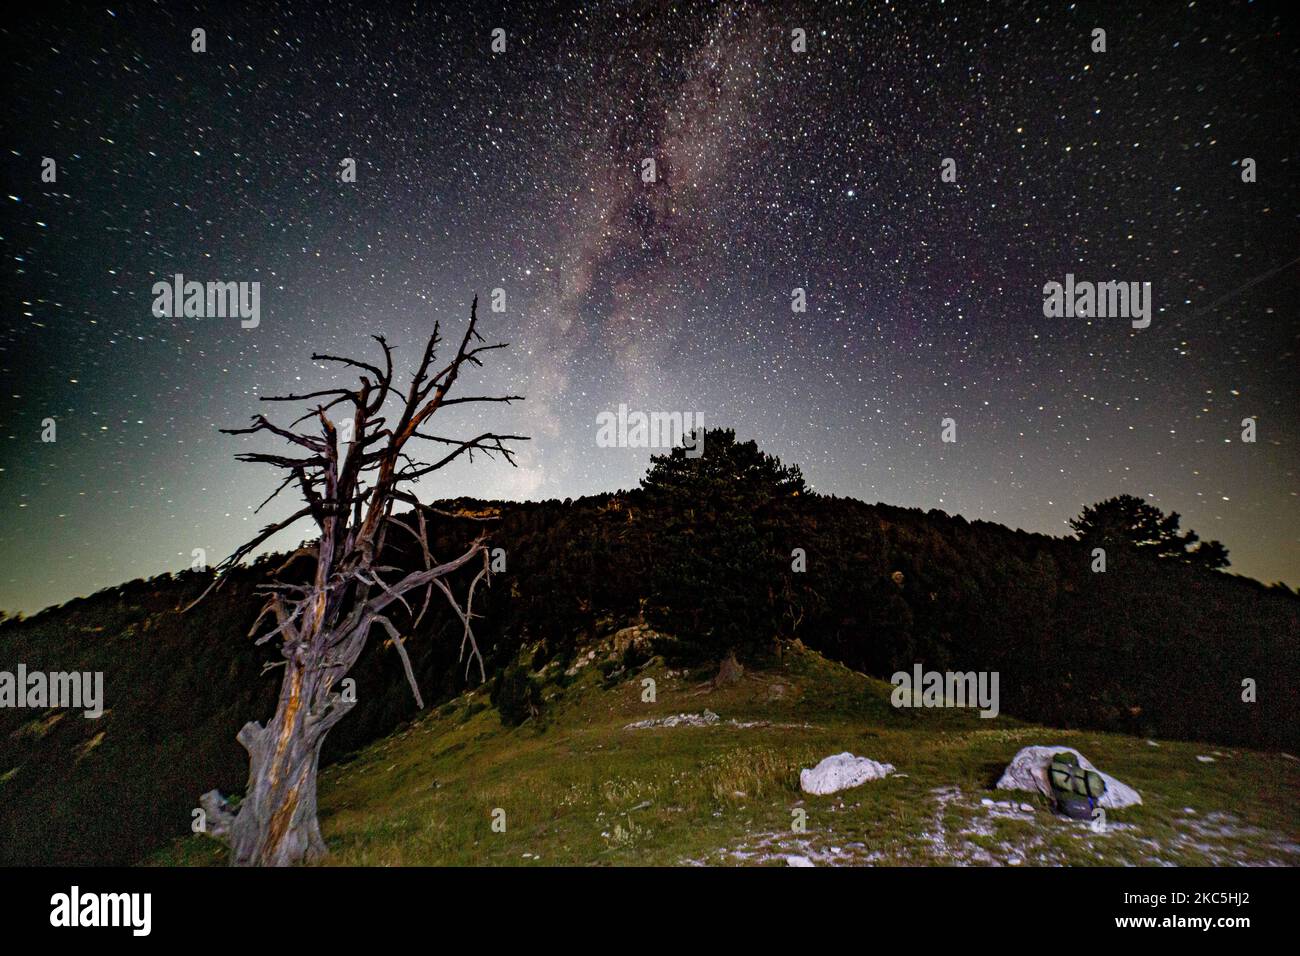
[{"left": 153, "top": 646, "right": 1300, "bottom": 865}]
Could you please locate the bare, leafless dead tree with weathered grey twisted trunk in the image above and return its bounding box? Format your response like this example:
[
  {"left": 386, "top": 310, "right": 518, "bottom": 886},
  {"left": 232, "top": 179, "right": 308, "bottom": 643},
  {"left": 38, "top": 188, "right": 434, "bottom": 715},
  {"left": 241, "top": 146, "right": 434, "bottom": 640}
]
[{"left": 191, "top": 297, "right": 524, "bottom": 866}]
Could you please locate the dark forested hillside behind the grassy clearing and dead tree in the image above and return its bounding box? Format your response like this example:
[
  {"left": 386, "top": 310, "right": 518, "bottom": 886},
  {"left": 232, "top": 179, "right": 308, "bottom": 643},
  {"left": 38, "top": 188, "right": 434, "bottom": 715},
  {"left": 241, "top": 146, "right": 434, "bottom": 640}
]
[{"left": 0, "top": 432, "right": 1300, "bottom": 864}]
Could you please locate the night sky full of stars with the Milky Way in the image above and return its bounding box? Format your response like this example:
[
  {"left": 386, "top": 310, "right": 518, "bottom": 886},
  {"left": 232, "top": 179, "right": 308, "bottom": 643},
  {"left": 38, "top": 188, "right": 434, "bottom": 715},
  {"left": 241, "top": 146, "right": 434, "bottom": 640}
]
[{"left": 0, "top": 0, "right": 1300, "bottom": 613}]
